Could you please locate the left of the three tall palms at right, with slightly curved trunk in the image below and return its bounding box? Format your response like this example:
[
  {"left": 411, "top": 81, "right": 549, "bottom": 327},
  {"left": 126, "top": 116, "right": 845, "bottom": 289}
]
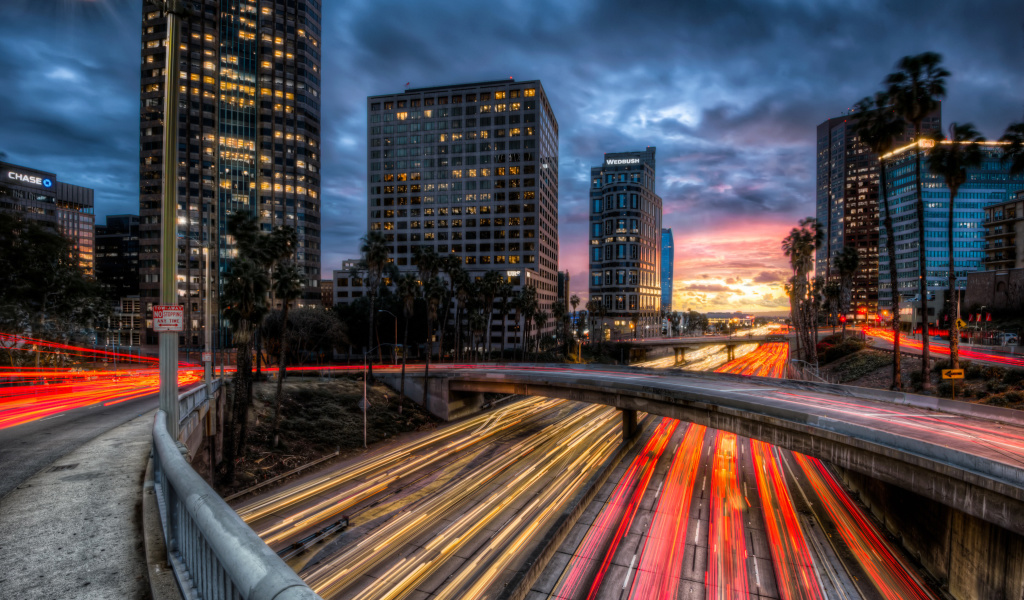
[{"left": 852, "top": 88, "right": 906, "bottom": 391}]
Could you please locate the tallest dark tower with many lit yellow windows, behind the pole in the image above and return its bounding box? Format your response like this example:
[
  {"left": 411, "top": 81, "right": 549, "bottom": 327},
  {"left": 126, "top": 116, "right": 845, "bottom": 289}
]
[{"left": 139, "top": 0, "right": 321, "bottom": 347}]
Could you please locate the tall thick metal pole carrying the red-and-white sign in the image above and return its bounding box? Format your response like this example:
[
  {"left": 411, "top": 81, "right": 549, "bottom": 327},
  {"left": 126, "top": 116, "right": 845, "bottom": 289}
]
[{"left": 160, "top": 0, "right": 184, "bottom": 439}]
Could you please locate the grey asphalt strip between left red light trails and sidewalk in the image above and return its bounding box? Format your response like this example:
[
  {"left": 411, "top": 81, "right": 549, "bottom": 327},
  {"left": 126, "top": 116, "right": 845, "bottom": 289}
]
[{"left": 0, "top": 394, "right": 159, "bottom": 501}]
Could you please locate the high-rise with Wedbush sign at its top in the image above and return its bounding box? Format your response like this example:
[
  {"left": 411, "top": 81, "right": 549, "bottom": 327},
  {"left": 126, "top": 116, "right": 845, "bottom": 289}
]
[{"left": 590, "top": 146, "right": 662, "bottom": 339}]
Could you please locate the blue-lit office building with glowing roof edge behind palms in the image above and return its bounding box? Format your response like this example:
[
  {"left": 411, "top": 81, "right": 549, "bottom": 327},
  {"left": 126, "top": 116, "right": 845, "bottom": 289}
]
[{"left": 879, "top": 140, "right": 1024, "bottom": 323}]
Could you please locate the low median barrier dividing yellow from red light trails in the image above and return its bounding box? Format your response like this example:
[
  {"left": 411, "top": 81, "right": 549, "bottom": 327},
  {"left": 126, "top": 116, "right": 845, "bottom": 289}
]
[{"left": 498, "top": 416, "right": 649, "bottom": 600}]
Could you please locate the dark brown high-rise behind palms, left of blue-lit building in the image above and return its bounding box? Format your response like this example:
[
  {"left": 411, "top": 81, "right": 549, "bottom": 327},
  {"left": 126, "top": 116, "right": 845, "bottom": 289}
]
[{"left": 814, "top": 106, "right": 942, "bottom": 316}]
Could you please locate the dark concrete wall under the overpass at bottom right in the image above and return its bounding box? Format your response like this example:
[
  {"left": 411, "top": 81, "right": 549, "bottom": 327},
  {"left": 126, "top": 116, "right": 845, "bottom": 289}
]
[{"left": 836, "top": 467, "right": 1024, "bottom": 600}]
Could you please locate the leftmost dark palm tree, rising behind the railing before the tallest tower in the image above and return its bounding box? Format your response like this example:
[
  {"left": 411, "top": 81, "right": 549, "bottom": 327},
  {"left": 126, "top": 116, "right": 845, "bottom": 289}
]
[{"left": 221, "top": 256, "right": 270, "bottom": 481}]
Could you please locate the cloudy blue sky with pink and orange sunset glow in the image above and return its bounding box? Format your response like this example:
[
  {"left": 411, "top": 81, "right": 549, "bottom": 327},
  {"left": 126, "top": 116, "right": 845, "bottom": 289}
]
[{"left": 0, "top": 0, "right": 1024, "bottom": 312}]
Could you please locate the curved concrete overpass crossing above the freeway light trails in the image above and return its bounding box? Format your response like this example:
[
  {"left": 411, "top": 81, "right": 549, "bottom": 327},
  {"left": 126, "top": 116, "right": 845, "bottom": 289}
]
[{"left": 393, "top": 366, "right": 1024, "bottom": 534}]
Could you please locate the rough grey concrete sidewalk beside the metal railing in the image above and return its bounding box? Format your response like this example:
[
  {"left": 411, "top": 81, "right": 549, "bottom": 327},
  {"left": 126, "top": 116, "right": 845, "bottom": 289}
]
[{"left": 0, "top": 411, "right": 155, "bottom": 600}]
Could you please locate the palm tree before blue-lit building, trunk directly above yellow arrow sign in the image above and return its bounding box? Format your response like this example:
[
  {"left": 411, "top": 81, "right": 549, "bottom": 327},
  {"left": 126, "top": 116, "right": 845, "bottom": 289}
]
[{"left": 928, "top": 123, "right": 985, "bottom": 369}]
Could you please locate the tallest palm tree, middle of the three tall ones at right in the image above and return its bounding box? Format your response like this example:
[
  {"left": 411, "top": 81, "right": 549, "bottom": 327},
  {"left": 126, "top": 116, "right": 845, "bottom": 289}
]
[{"left": 886, "top": 52, "right": 949, "bottom": 390}]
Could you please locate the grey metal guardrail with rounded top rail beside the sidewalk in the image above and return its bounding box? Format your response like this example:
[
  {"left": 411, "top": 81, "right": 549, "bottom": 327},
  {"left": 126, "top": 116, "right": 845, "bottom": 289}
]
[{"left": 153, "top": 386, "right": 319, "bottom": 600}]
